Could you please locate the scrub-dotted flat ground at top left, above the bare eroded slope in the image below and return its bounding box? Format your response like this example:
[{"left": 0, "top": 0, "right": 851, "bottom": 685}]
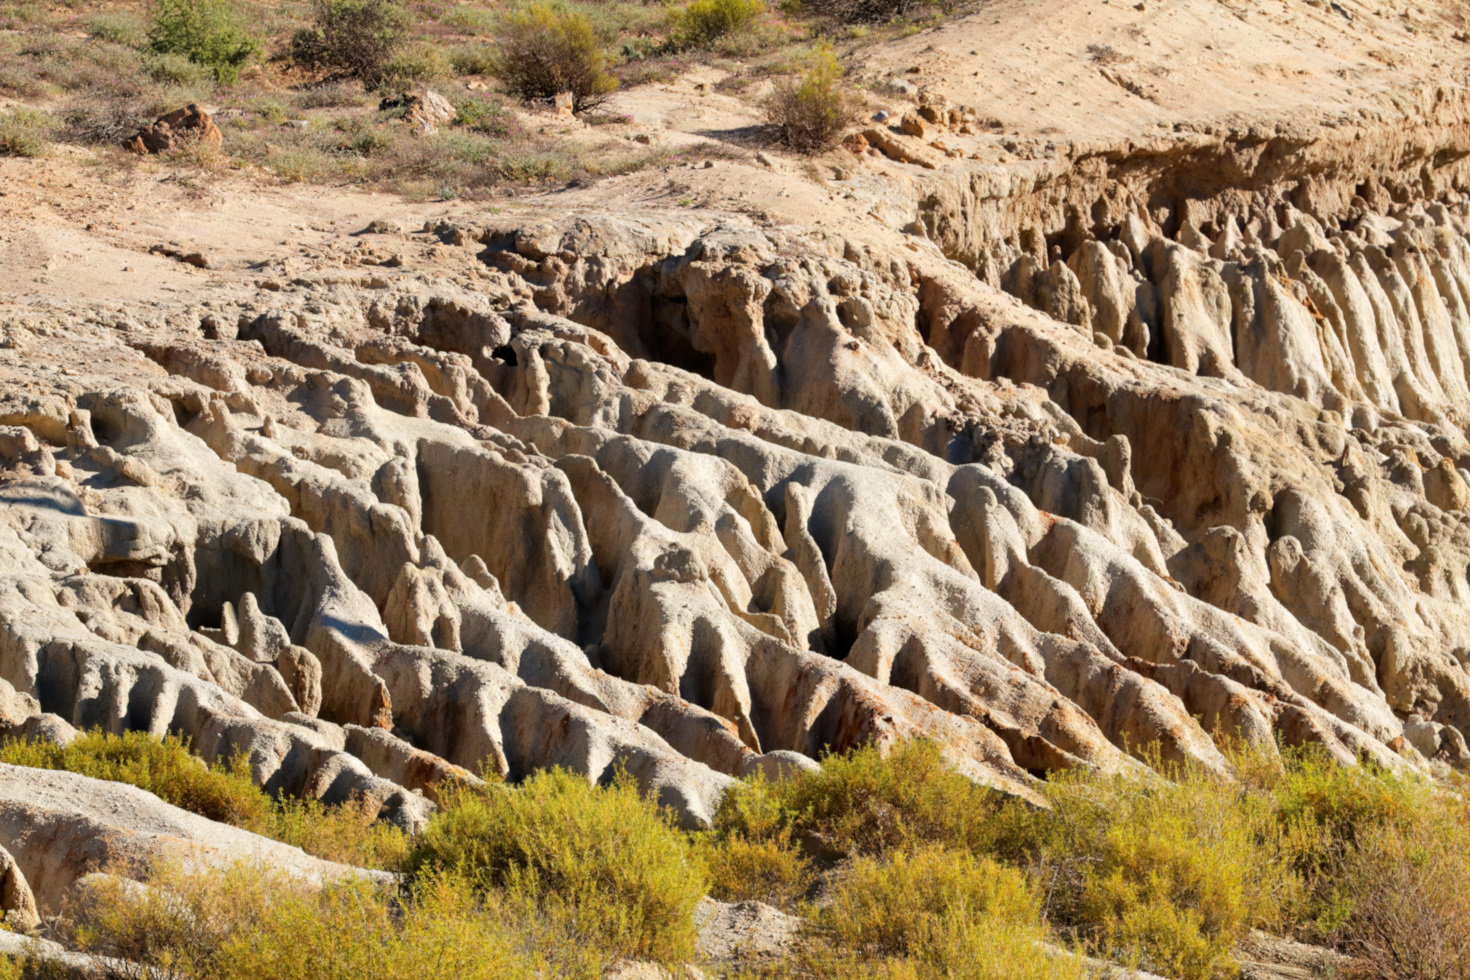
[{"left": 0, "top": 0, "right": 917, "bottom": 189}]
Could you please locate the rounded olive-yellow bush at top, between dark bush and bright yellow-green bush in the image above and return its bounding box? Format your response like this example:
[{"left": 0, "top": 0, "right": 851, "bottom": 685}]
[{"left": 494, "top": 3, "right": 617, "bottom": 112}]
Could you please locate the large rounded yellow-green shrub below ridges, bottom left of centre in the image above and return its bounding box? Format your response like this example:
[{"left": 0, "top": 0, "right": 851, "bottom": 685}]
[{"left": 410, "top": 770, "right": 706, "bottom": 961}]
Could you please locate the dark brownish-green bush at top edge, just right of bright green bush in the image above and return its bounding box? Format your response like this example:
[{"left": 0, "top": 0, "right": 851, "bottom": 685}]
[{"left": 291, "top": 0, "right": 412, "bottom": 85}]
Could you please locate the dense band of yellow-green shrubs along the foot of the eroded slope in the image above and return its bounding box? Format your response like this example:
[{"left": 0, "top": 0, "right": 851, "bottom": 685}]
[{"left": 0, "top": 733, "right": 1470, "bottom": 980}]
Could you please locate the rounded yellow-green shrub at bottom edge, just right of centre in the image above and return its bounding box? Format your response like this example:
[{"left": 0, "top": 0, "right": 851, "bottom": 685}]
[{"left": 816, "top": 846, "right": 1083, "bottom": 980}]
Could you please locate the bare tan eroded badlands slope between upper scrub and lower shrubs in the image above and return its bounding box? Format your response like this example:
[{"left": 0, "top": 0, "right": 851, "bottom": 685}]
[{"left": 0, "top": 0, "right": 1470, "bottom": 940}]
